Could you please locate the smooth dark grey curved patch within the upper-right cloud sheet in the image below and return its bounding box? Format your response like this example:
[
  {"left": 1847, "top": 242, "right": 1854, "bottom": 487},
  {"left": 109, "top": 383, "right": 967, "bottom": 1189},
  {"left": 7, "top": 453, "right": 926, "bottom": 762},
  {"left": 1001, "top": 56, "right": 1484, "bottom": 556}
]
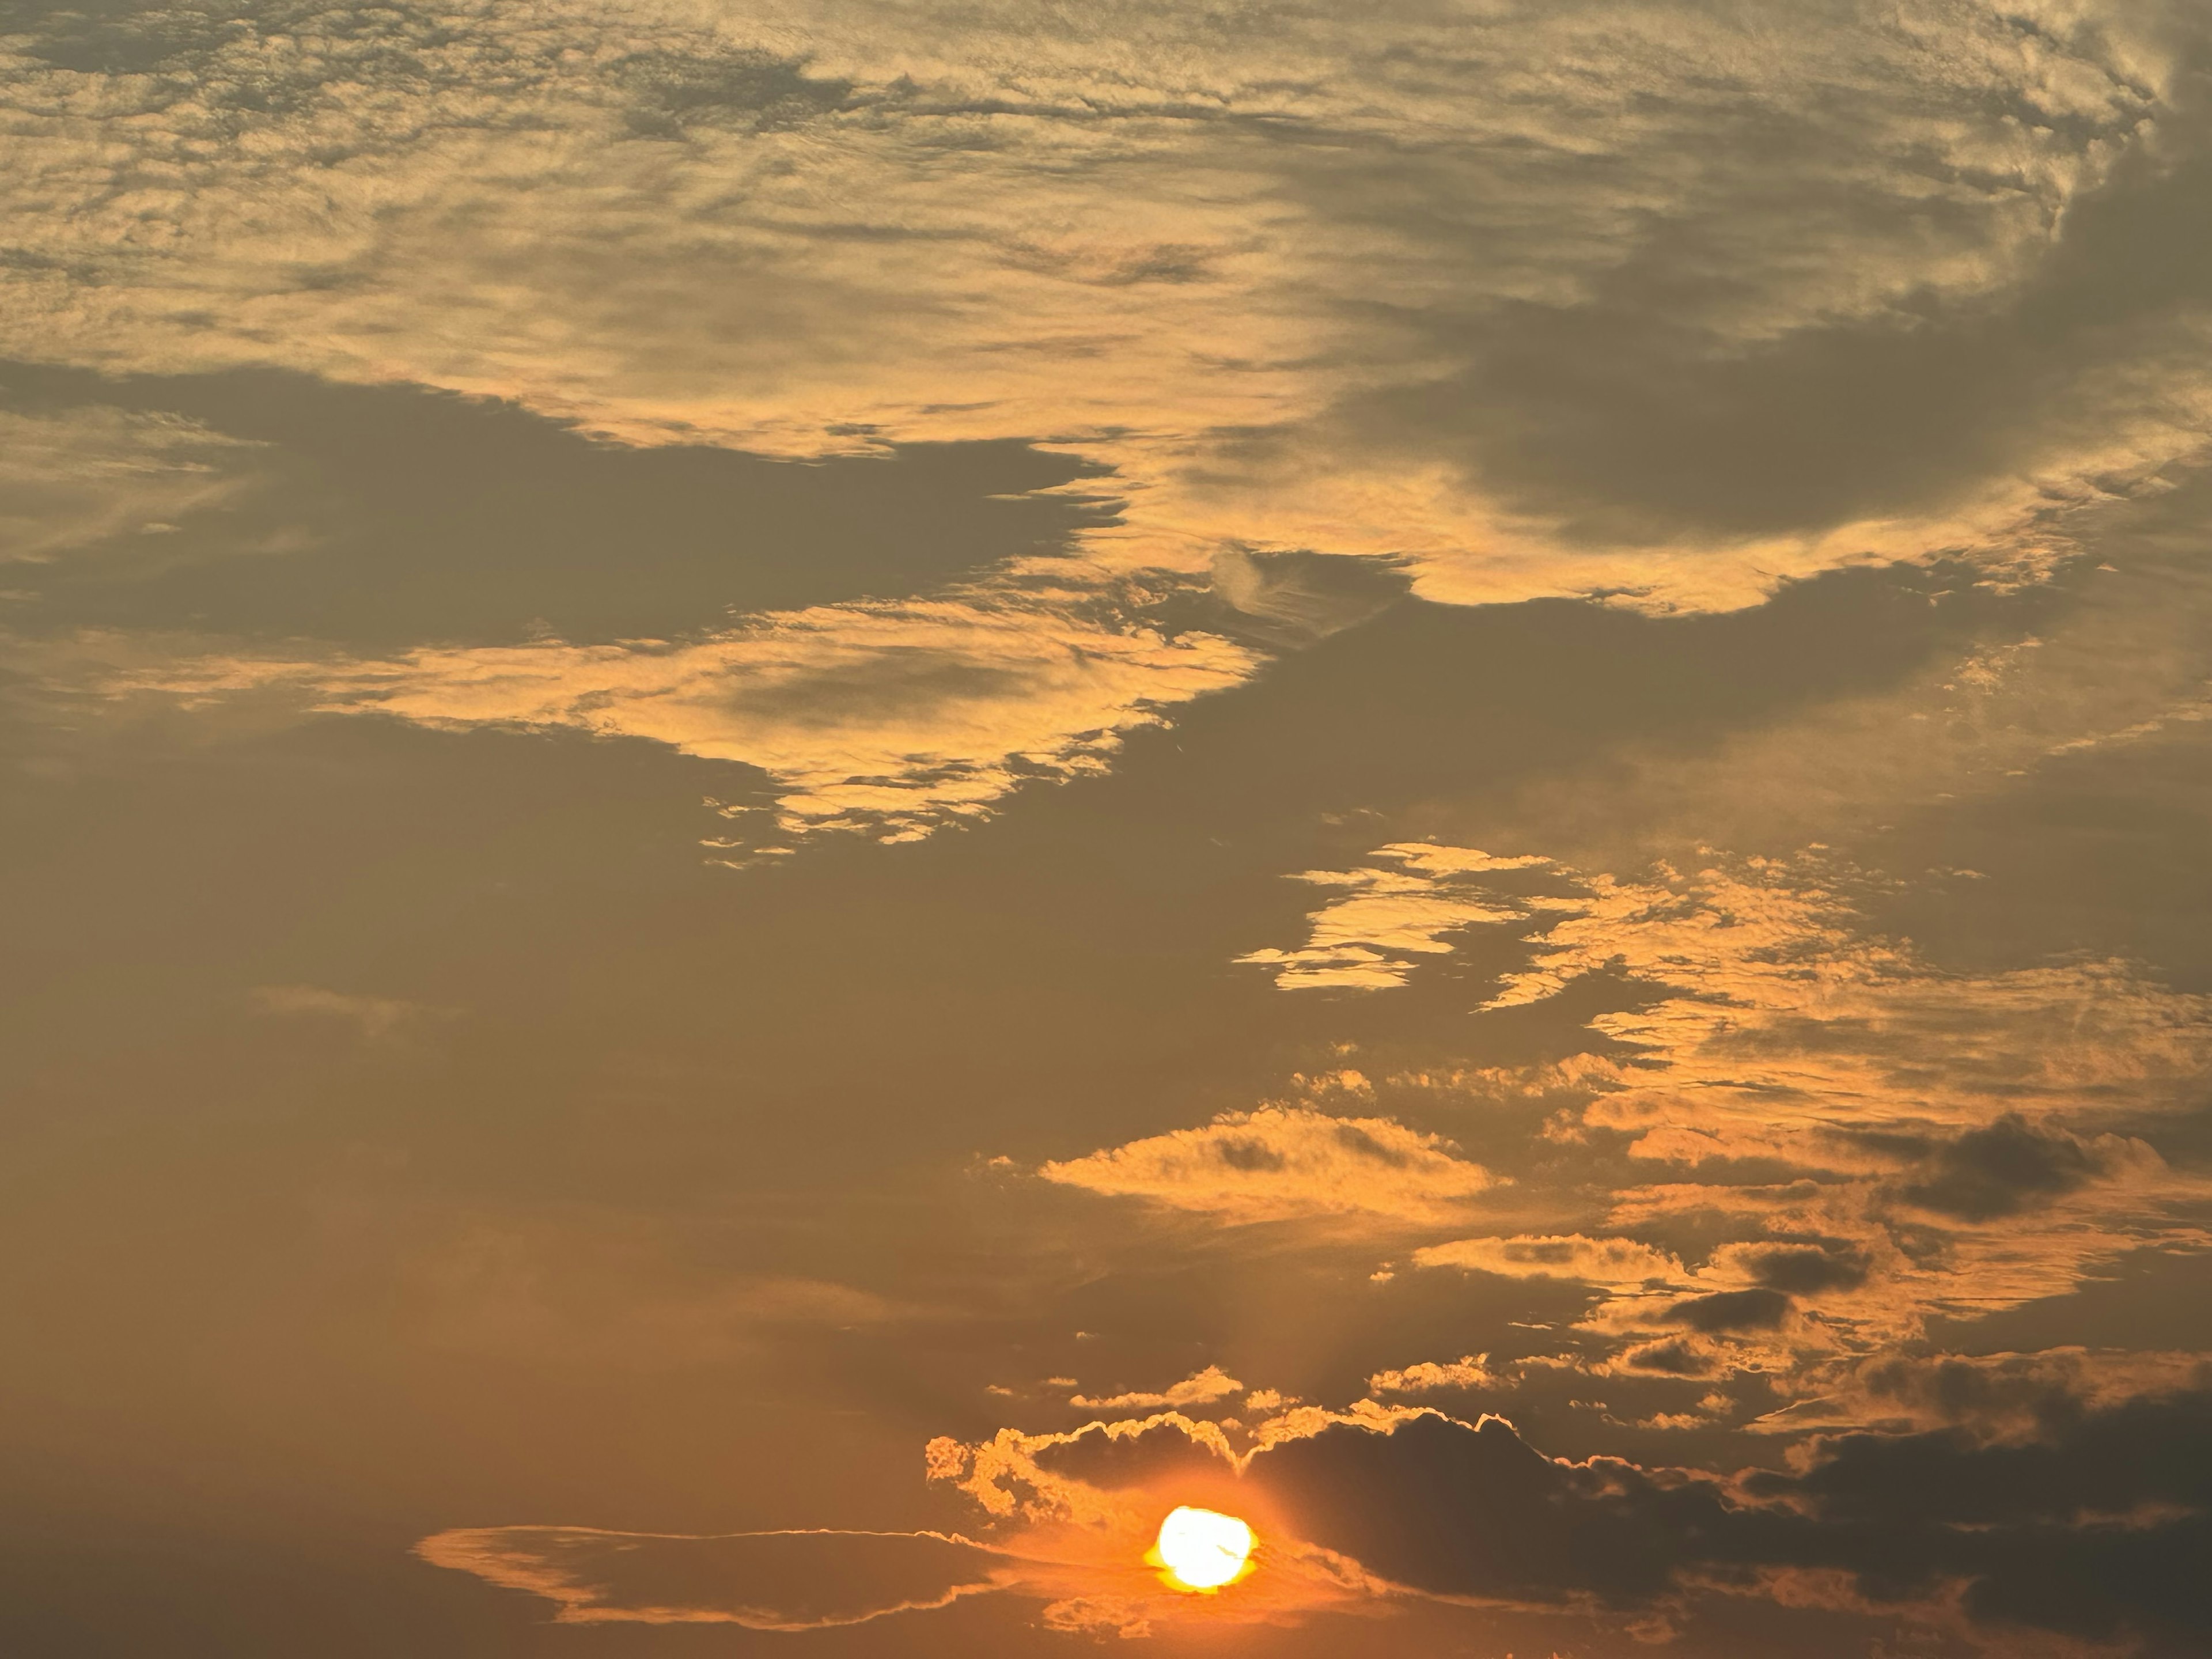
[{"left": 1343, "top": 104, "right": 2212, "bottom": 542}]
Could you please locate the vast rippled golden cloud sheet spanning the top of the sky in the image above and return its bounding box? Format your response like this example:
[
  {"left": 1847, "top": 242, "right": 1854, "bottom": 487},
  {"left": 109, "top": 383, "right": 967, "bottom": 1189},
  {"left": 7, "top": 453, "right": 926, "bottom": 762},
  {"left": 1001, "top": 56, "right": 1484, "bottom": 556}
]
[{"left": 0, "top": 0, "right": 2205, "bottom": 608}]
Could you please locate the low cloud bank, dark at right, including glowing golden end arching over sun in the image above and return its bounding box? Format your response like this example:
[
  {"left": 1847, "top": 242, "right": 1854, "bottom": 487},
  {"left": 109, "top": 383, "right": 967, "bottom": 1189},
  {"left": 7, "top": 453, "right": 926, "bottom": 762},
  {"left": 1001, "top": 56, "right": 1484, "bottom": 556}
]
[{"left": 911, "top": 1380, "right": 2212, "bottom": 1654}]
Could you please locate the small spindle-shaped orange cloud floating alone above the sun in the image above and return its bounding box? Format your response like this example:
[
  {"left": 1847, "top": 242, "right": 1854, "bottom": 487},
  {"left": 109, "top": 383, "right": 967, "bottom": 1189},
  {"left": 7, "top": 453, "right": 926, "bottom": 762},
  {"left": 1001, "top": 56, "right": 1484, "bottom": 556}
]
[{"left": 1037, "top": 1106, "right": 1495, "bottom": 1224}]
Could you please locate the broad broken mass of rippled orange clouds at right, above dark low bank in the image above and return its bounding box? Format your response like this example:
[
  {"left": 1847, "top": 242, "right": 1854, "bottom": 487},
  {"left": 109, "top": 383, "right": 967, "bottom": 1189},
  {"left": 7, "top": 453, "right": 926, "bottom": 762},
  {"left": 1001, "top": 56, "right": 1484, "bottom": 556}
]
[{"left": 1265, "top": 843, "right": 2212, "bottom": 1389}]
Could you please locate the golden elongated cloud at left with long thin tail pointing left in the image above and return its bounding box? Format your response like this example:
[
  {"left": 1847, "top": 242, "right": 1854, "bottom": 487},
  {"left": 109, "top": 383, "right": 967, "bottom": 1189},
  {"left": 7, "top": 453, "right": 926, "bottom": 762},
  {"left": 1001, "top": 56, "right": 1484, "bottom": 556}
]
[{"left": 90, "top": 582, "right": 1256, "bottom": 840}]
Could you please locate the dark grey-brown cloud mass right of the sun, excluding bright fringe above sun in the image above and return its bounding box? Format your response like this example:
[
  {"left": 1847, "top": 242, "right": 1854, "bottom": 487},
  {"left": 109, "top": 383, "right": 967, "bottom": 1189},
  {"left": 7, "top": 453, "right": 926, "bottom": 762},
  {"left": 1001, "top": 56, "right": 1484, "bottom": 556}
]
[{"left": 1252, "top": 1391, "right": 2212, "bottom": 1654}]
